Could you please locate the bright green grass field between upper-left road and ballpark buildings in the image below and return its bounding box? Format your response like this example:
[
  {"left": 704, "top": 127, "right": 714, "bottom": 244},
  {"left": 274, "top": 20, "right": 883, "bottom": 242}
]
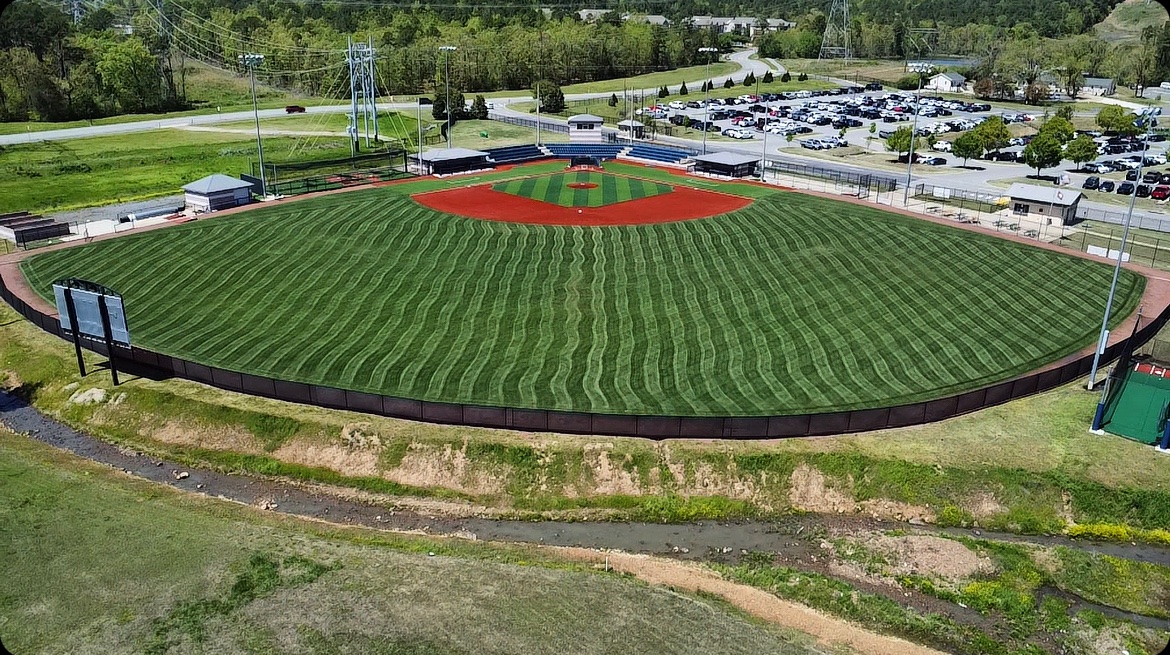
[{"left": 0, "top": 129, "right": 350, "bottom": 213}]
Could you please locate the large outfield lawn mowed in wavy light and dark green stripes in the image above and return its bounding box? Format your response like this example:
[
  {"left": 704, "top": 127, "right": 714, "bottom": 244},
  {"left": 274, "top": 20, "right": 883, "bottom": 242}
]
[{"left": 25, "top": 168, "right": 1143, "bottom": 415}]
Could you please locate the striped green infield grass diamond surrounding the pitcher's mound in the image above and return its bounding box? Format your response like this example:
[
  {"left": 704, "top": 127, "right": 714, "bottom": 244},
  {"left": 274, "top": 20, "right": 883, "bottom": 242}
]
[{"left": 491, "top": 171, "right": 673, "bottom": 207}]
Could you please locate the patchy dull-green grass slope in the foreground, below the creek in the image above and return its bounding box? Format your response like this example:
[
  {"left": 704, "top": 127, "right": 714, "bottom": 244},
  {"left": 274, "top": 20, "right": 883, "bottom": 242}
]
[{"left": 0, "top": 430, "right": 821, "bottom": 655}]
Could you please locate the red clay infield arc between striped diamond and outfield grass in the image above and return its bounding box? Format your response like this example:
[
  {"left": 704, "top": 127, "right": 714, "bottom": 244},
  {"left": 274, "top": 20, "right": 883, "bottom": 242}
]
[{"left": 411, "top": 184, "right": 751, "bottom": 226}]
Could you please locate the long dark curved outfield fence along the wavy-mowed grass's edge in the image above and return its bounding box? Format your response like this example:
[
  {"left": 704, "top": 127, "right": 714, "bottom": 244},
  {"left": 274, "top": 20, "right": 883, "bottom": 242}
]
[{"left": 0, "top": 271, "right": 1170, "bottom": 440}]
